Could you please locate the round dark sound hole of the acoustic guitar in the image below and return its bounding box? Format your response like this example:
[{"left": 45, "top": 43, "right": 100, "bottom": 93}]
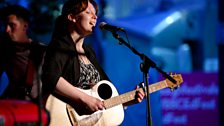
[{"left": 98, "top": 84, "right": 112, "bottom": 100}]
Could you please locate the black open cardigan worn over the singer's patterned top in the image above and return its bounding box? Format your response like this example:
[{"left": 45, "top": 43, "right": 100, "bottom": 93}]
[{"left": 42, "top": 35, "right": 109, "bottom": 94}]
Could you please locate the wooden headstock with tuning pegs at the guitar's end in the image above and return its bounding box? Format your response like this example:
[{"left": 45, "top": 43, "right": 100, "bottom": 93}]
[{"left": 165, "top": 74, "right": 183, "bottom": 91}]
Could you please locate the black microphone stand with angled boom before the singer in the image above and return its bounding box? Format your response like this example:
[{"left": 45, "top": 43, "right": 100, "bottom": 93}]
[{"left": 112, "top": 32, "right": 176, "bottom": 126}]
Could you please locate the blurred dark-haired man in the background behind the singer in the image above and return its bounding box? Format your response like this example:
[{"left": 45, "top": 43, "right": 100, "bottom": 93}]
[{"left": 0, "top": 5, "right": 46, "bottom": 101}]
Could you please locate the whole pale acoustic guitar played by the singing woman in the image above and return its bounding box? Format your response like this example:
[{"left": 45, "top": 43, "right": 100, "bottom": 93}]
[{"left": 45, "top": 74, "right": 183, "bottom": 126}]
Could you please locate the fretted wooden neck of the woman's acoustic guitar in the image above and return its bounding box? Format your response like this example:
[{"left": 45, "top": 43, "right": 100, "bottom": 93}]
[{"left": 104, "top": 80, "right": 168, "bottom": 109}]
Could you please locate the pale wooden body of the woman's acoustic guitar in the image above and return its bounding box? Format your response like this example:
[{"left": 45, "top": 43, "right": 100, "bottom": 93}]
[{"left": 46, "top": 80, "right": 124, "bottom": 126}]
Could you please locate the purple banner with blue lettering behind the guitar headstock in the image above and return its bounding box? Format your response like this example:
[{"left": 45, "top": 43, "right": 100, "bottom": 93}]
[{"left": 161, "top": 73, "right": 219, "bottom": 126}]
